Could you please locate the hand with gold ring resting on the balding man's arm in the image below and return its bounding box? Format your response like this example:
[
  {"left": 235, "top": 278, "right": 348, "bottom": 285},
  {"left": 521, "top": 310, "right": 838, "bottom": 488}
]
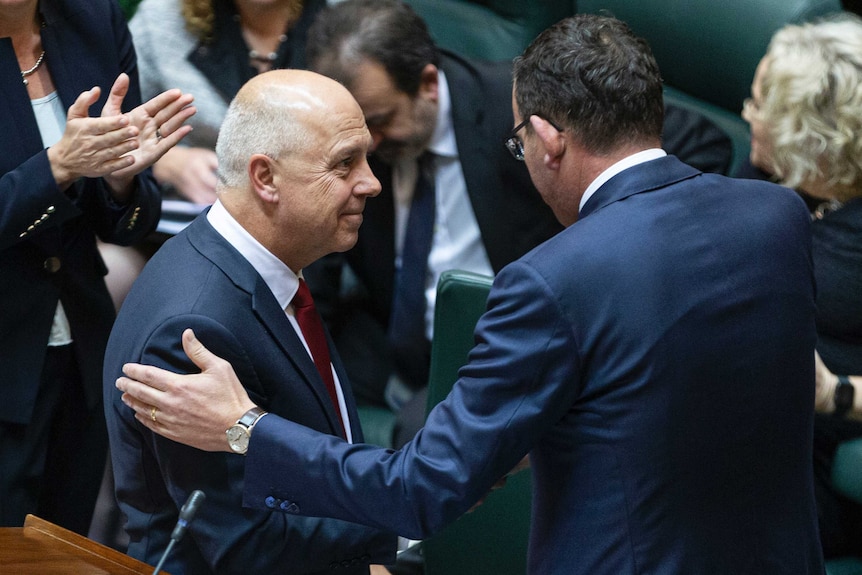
[{"left": 116, "top": 329, "right": 255, "bottom": 452}]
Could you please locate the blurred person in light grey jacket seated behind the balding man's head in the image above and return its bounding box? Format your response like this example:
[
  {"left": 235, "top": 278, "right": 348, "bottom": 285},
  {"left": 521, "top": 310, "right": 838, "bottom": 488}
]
[{"left": 129, "top": 0, "right": 326, "bottom": 204}]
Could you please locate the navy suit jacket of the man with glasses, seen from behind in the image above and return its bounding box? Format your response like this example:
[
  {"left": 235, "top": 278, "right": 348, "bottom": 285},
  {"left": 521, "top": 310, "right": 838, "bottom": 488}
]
[{"left": 245, "top": 156, "right": 823, "bottom": 575}]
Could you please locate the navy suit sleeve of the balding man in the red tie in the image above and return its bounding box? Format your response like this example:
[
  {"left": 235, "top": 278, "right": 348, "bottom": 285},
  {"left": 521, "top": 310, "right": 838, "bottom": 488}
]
[{"left": 114, "top": 315, "right": 396, "bottom": 573}]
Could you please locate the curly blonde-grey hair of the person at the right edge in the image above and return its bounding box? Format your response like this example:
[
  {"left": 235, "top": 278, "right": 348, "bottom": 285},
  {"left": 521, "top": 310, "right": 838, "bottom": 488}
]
[{"left": 756, "top": 13, "right": 862, "bottom": 194}]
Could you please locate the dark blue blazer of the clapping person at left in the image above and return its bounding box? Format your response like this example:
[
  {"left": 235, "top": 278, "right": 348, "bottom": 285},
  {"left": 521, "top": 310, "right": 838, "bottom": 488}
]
[{"left": 0, "top": 0, "right": 160, "bottom": 424}]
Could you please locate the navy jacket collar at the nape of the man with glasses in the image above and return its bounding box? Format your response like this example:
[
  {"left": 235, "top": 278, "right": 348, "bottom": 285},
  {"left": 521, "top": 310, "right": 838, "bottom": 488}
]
[{"left": 579, "top": 156, "right": 701, "bottom": 219}]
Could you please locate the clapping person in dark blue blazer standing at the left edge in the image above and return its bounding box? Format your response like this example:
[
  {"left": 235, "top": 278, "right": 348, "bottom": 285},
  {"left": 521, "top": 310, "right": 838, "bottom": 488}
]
[{"left": 0, "top": 0, "right": 194, "bottom": 535}]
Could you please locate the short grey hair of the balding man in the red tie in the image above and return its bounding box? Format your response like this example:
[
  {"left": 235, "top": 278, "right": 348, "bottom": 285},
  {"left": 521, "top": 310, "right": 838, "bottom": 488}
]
[{"left": 216, "top": 86, "right": 311, "bottom": 188}]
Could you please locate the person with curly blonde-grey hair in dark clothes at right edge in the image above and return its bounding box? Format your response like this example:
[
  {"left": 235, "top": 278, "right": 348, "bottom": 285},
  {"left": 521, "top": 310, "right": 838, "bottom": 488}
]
[{"left": 739, "top": 13, "right": 862, "bottom": 558}]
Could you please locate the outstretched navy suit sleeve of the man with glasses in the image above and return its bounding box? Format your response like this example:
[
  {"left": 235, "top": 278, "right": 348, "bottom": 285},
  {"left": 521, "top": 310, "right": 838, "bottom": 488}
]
[{"left": 244, "top": 263, "right": 579, "bottom": 538}]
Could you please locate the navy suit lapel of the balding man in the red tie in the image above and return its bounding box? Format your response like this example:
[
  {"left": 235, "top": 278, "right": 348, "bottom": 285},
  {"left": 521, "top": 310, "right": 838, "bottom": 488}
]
[{"left": 182, "top": 215, "right": 353, "bottom": 435}]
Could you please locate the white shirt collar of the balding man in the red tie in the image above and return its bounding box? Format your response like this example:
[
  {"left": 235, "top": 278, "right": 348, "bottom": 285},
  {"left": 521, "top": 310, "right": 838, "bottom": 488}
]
[{"left": 207, "top": 200, "right": 299, "bottom": 309}]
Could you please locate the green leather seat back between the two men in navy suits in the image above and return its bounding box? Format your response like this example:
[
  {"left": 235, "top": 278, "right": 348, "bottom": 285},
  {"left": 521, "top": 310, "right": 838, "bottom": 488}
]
[{"left": 422, "top": 271, "right": 532, "bottom": 575}]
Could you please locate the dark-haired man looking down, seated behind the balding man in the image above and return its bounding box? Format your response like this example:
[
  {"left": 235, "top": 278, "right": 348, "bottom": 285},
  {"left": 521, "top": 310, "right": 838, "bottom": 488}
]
[{"left": 306, "top": 0, "right": 731, "bottom": 446}]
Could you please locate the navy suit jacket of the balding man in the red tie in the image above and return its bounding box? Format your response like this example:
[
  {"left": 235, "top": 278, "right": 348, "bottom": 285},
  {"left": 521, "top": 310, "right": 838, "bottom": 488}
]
[{"left": 104, "top": 212, "right": 396, "bottom": 575}]
